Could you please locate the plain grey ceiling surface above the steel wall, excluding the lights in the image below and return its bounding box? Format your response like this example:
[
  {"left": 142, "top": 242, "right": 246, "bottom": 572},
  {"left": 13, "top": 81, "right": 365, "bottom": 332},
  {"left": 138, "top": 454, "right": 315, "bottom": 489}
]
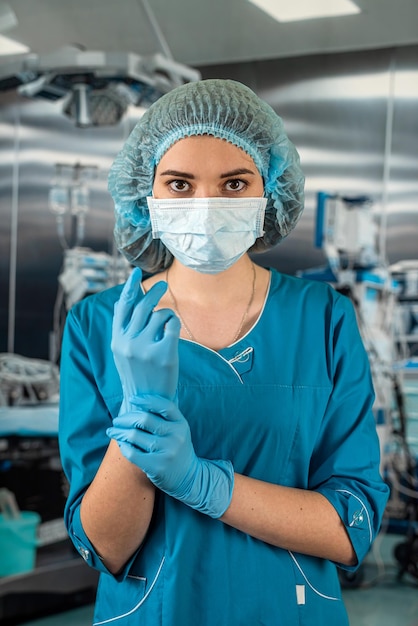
[{"left": 0, "top": 0, "right": 418, "bottom": 66}]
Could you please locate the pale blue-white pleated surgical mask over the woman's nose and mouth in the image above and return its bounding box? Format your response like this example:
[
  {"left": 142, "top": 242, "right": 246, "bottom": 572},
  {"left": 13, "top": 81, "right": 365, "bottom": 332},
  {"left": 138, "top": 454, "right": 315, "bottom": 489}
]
[{"left": 147, "top": 197, "right": 267, "bottom": 274}]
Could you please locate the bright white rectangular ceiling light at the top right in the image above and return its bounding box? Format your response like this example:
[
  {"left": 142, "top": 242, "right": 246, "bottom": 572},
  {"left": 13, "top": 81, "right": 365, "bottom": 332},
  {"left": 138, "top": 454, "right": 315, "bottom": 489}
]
[{"left": 250, "top": 0, "right": 361, "bottom": 22}]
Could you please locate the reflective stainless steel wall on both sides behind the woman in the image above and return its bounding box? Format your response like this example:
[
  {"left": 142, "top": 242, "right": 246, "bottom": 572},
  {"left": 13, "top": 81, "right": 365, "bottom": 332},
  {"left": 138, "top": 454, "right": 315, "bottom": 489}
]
[{"left": 0, "top": 46, "right": 418, "bottom": 358}]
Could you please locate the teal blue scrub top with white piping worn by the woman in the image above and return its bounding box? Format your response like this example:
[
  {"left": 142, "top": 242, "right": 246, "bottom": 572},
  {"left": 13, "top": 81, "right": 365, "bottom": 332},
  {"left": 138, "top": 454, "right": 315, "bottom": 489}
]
[{"left": 59, "top": 270, "right": 388, "bottom": 626}]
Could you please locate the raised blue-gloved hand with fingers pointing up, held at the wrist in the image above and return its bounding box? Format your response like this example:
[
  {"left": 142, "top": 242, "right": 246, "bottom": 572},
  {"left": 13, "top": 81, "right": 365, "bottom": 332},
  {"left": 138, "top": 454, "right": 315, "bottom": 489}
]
[{"left": 111, "top": 268, "right": 180, "bottom": 410}]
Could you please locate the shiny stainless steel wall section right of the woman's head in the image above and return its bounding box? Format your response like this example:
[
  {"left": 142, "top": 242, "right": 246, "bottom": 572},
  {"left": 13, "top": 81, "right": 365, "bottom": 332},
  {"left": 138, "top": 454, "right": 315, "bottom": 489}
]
[{"left": 202, "top": 47, "right": 418, "bottom": 272}]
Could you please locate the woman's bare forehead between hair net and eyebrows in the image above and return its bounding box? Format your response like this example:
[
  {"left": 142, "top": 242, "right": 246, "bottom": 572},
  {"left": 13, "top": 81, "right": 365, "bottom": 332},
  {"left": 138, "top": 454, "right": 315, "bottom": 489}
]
[{"left": 157, "top": 135, "right": 257, "bottom": 170}]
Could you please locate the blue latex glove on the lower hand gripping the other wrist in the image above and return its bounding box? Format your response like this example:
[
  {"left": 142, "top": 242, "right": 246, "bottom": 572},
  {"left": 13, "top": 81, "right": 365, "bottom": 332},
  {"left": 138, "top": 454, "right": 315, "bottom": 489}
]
[{"left": 107, "top": 396, "right": 234, "bottom": 518}]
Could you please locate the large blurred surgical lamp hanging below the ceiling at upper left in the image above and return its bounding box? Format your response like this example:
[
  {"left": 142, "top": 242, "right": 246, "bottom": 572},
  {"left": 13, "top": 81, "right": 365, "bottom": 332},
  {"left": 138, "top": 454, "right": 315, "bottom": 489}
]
[{"left": 0, "top": 48, "right": 201, "bottom": 128}]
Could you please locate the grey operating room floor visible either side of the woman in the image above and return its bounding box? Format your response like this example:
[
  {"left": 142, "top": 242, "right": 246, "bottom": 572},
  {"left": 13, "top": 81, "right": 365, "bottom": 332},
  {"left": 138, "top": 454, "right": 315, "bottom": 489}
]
[{"left": 18, "top": 533, "right": 418, "bottom": 626}]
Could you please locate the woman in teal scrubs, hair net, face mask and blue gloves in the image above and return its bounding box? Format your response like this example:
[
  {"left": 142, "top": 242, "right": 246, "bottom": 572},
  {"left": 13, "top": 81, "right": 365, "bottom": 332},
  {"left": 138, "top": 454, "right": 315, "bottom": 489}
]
[{"left": 60, "top": 80, "right": 388, "bottom": 626}]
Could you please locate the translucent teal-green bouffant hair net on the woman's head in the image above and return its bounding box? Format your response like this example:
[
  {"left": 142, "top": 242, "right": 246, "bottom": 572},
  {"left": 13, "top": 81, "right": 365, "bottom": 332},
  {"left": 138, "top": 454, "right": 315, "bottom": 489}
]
[{"left": 109, "top": 79, "right": 304, "bottom": 272}]
